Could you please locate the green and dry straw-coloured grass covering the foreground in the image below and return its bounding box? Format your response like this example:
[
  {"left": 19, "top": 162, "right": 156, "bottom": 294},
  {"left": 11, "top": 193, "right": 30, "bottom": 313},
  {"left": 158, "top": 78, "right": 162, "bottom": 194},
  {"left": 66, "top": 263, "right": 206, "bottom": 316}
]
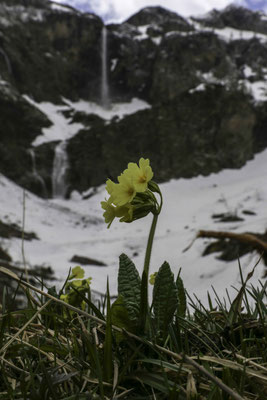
[{"left": 0, "top": 260, "right": 267, "bottom": 400}]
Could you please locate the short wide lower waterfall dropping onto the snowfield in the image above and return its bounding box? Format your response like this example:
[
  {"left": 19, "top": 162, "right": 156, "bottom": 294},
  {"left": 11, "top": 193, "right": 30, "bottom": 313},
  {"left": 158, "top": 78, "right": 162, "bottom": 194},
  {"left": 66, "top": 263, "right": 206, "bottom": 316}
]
[{"left": 52, "top": 140, "right": 69, "bottom": 199}]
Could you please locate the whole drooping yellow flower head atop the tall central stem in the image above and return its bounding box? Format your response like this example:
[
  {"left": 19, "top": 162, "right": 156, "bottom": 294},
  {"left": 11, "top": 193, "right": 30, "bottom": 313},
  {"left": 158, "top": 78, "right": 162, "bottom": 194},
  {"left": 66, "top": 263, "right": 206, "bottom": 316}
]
[{"left": 101, "top": 158, "right": 162, "bottom": 228}]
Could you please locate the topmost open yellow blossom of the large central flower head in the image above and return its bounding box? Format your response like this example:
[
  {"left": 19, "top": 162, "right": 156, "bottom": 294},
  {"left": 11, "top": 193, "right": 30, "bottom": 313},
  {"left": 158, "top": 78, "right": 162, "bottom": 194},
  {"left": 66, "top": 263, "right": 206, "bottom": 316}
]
[{"left": 123, "top": 158, "right": 153, "bottom": 192}]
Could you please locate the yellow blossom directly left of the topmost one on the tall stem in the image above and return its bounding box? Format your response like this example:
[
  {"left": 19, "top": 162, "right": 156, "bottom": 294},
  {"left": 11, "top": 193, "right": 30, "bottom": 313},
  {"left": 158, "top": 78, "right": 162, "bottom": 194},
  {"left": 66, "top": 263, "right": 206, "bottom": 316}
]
[{"left": 111, "top": 174, "right": 136, "bottom": 206}]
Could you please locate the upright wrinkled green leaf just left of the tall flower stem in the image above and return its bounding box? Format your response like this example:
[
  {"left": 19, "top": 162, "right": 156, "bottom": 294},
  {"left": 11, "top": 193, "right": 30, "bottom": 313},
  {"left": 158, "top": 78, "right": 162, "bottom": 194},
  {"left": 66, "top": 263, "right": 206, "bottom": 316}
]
[{"left": 118, "top": 254, "right": 141, "bottom": 322}]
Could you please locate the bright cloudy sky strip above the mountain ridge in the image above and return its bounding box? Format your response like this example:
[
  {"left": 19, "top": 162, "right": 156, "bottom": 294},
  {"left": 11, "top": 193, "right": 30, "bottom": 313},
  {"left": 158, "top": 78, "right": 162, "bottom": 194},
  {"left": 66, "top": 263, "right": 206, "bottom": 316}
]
[{"left": 54, "top": 0, "right": 267, "bottom": 22}]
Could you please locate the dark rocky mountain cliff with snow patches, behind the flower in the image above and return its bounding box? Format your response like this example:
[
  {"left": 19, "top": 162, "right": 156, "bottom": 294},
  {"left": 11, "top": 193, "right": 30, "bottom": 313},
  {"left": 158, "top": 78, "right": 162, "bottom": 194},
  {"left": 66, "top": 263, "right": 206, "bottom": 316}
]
[{"left": 0, "top": 0, "right": 267, "bottom": 196}]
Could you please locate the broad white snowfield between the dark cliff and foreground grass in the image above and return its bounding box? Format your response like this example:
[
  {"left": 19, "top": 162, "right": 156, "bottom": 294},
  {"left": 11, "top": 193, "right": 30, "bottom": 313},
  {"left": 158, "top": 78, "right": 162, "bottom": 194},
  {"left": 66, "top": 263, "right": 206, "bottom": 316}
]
[{"left": 0, "top": 146, "right": 267, "bottom": 301}]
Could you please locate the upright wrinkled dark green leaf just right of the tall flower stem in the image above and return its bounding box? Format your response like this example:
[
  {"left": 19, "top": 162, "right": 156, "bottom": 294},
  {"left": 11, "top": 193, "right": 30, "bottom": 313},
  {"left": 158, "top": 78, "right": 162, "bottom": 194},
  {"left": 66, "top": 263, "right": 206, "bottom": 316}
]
[{"left": 153, "top": 261, "right": 178, "bottom": 334}]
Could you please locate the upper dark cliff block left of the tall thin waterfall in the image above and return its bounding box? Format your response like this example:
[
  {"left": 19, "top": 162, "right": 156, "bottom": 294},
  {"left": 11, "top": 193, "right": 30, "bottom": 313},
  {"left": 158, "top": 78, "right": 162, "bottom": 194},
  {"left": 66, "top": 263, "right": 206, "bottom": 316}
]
[{"left": 0, "top": 0, "right": 102, "bottom": 102}]
